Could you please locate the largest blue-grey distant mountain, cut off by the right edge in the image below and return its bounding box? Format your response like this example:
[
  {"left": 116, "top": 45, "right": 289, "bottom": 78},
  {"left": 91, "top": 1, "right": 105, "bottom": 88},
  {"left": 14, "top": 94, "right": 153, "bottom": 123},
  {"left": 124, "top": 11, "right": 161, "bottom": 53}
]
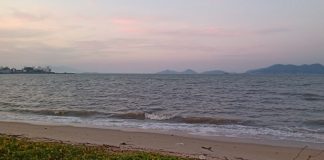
[{"left": 246, "top": 64, "right": 324, "bottom": 74}]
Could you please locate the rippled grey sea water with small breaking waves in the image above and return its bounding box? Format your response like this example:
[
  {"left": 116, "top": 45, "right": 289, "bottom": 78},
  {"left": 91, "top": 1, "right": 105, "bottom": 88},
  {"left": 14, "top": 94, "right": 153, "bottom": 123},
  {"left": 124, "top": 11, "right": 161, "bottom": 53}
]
[{"left": 0, "top": 74, "right": 324, "bottom": 144}]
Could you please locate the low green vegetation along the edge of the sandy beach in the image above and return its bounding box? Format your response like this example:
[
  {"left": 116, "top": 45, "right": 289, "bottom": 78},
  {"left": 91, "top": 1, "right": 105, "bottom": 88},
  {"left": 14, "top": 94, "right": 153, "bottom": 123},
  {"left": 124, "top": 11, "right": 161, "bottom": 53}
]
[{"left": 0, "top": 135, "right": 189, "bottom": 160}]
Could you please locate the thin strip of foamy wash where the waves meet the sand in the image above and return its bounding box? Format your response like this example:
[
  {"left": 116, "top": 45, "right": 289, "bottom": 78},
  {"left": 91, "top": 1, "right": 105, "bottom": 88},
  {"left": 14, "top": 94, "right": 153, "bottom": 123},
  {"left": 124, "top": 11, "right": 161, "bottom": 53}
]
[{"left": 0, "top": 120, "right": 324, "bottom": 150}]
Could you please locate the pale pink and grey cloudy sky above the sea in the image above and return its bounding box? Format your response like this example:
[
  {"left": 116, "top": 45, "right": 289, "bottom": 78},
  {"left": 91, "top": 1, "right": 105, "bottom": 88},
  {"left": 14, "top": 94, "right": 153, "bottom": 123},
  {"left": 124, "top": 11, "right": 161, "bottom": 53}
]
[{"left": 0, "top": 0, "right": 324, "bottom": 73}]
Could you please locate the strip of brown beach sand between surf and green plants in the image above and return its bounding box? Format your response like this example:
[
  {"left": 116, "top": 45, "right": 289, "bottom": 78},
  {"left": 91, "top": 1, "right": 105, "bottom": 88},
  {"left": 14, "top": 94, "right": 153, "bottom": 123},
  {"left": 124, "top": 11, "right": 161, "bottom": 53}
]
[{"left": 0, "top": 122, "right": 324, "bottom": 160}]
